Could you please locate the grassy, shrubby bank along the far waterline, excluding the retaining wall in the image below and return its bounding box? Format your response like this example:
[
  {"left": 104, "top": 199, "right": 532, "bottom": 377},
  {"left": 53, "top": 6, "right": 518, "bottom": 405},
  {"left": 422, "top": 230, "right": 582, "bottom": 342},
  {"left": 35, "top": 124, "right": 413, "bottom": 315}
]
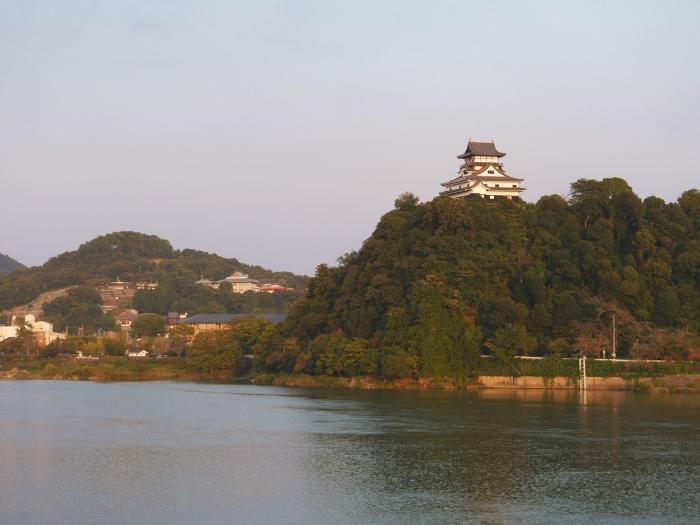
[{"left": 0, "top": 356, "right": 700, "bottom": 392}]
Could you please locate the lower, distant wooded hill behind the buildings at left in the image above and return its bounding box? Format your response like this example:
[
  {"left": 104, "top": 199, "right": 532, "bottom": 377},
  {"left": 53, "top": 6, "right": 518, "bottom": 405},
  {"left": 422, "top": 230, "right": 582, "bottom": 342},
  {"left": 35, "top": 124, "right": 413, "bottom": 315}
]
[{"left": 0, "top": 232, "right": 307, "bottom": 322}]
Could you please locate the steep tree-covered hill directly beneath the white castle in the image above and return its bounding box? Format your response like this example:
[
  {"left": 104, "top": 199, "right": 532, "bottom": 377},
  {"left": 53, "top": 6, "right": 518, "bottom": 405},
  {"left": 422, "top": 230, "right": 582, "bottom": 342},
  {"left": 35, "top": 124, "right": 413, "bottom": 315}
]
[{"left": 259, "top": 178, "right": 700, "bottom": 377}]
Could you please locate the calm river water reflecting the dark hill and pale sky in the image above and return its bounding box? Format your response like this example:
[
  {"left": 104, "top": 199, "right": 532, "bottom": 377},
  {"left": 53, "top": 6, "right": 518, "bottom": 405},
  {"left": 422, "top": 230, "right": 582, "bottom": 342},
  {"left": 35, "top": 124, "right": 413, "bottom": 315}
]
[{"left": 0, "top": 381, "right": 700, "bottom": 525}]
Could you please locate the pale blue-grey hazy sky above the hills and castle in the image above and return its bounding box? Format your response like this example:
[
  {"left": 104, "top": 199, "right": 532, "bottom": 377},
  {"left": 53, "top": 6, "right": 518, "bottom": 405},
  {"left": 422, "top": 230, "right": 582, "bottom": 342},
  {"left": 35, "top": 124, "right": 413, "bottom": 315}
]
[{"left": 0, "top": 0, "right": 700, "bottom": 274}]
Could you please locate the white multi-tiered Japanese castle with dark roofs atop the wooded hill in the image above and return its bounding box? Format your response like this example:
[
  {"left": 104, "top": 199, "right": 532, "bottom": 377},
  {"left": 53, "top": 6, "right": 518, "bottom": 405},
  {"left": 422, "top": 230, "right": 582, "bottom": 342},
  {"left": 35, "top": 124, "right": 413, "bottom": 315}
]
[{"left": 440, "top": 140, "right": 525, "bottom": 200}]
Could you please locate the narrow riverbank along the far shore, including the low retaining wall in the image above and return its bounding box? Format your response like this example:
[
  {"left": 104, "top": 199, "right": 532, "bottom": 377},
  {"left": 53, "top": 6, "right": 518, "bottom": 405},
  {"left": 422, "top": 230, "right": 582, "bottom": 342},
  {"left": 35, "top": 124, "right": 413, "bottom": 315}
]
[{"left": 0, "top": 356, "right": 700, "bottom": 393}]
